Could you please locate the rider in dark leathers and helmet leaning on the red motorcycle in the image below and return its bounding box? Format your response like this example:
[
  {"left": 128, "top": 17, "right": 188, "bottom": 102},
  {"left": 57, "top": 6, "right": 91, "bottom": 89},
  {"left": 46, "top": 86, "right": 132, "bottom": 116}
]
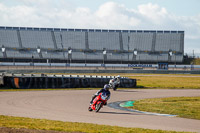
[{"left": 90, "top": 84, "right": 110, "bottom": 105}]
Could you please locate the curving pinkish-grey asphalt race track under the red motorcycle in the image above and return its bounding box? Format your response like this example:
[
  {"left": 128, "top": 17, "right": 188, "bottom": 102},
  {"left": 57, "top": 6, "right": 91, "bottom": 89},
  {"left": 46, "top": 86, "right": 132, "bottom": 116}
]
[{"left": 0, "top": 89, "right": 200, "bottom": 132}]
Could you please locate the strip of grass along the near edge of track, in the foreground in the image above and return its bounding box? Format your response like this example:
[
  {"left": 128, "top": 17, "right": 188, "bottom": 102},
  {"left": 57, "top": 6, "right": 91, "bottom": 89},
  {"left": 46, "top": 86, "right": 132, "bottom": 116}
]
[{"left": 0, "top": 115, "right": 191, "bottom": 133}]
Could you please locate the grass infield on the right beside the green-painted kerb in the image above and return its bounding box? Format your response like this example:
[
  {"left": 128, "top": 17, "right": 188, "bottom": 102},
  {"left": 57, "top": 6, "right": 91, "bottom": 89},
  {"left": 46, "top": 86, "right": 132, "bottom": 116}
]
[{"left": 131, "top": 97, "right": 200, "bottom": 120}]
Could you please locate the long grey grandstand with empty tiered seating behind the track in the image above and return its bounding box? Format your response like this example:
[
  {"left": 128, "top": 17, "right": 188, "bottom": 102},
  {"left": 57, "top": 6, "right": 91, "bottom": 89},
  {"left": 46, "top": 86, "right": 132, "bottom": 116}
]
[{"left": 0, "top": 26, "right": 184, "bottom": 64}]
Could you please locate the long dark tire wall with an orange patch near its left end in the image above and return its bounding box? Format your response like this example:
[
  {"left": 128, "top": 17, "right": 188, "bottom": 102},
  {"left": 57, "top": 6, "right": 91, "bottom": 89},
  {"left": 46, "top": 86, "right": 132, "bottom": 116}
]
[{"left": 3, "top": 76, "right": 136, "bottom": 89}]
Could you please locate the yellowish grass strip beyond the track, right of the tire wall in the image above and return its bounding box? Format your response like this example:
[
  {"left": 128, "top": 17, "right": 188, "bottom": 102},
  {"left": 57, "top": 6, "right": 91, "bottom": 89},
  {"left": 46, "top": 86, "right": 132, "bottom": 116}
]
[{"left": 123, "top": 74, "right": 200, "bottom": 89}]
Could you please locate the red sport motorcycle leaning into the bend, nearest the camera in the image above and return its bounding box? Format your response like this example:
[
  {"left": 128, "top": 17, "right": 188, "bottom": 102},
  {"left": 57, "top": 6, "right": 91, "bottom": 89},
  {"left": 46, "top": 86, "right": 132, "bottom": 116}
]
[{"left": 88, "top": 93, "right": 108, "bottom": 112}]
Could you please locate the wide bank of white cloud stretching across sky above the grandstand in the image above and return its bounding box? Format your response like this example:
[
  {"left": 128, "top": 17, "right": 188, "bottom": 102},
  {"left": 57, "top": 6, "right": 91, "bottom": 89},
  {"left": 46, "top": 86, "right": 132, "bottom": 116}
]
[{"left": 0, "top": 0, "right": 200, "bottom": 52}]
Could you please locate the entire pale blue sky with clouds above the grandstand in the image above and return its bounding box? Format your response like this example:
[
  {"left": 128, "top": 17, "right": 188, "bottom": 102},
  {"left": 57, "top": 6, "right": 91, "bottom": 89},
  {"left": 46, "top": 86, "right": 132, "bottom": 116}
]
[{"left": 0, "top": 0, "right": 200, "bottom": 54}]
